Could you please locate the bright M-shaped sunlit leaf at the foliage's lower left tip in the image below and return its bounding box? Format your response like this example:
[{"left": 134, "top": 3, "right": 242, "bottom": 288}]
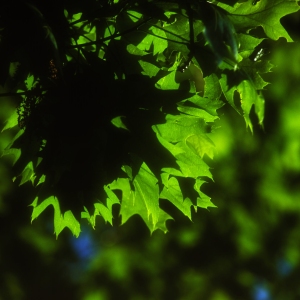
[{"left": 30, "top": 196, "right": 80, "bottom": 238}]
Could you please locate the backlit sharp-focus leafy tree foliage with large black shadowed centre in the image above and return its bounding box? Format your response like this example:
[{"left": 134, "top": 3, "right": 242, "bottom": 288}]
[{"left": 0, "top": 0, "right": 299, "bottom": 236}]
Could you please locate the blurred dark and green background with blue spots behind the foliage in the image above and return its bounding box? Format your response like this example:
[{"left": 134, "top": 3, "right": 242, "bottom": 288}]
[{"left": 0, "top": 8, "right": 300, "bottom": 300}]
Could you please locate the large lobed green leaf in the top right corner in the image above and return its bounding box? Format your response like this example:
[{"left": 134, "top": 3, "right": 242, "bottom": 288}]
[{"left": 218, "top": 0, "right": 299, "bottom": 42}]
